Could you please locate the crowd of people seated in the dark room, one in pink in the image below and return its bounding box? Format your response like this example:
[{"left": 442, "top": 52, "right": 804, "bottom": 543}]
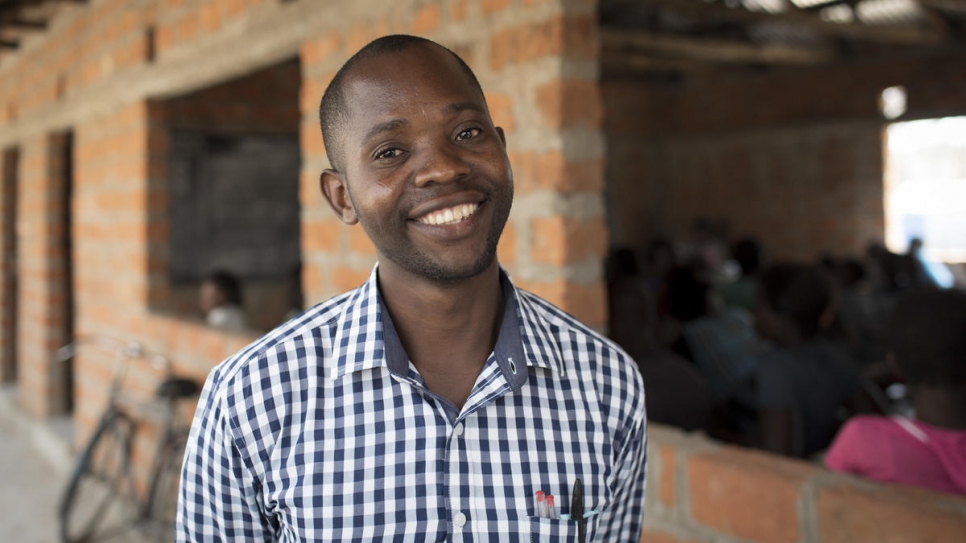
[{"left": 606, "top": 225, "right": 966, "bottom": 494}]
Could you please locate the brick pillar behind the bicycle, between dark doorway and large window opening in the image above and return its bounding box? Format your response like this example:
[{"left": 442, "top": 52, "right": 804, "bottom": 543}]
[{"left": 73, "top": 101, "right": 159, "bottom": 435}]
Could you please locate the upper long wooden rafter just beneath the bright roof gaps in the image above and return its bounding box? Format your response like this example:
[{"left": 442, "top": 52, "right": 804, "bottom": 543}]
[{"left": 627, "top": 0, "right": 946, "bottom": 45}]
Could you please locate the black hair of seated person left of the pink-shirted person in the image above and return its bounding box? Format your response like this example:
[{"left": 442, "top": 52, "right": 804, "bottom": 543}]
[{"left": 758, "top": 262, "right": 834, "bottom": 339}]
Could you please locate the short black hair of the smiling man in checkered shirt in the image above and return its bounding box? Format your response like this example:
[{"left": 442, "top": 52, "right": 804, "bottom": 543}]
[{"left": 319, "top": 34, "right": 486, "bottom": 171}]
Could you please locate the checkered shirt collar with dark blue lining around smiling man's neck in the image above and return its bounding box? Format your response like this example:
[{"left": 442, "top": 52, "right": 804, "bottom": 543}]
[{"left": 332, "top": 264, "right": 563, "bottom": 384}]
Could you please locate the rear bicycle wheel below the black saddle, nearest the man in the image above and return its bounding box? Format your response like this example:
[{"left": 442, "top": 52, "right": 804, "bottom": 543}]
[{"left": 145, "top": 435, "right": 188, "bottom": 543}]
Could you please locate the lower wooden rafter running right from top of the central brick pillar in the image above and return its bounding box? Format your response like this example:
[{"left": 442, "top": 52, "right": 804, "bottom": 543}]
[{"left": 601, "top": 28, "right": 834, "bottom": 64}]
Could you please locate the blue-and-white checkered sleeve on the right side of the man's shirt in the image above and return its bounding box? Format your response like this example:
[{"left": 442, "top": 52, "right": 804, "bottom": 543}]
[{"left": 595, "top": 397, "right": 647, "bottom": 541}]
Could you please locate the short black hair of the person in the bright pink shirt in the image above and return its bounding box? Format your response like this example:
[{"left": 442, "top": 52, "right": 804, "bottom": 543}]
[{"left": 888, "top": 287, "right": 966, "bottom": 387}]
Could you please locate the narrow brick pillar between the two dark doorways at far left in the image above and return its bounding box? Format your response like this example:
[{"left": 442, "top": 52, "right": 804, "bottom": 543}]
[{"left": 17, "top": 134, "right": 68, "bottom": 417}]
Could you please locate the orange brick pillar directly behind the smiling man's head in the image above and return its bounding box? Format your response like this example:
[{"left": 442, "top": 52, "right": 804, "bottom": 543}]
[{"left": 301, "top": 0, "right": 608, "bottom": 328}]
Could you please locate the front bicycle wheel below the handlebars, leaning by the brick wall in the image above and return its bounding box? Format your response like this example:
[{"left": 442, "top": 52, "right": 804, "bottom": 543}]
[{"left": 60, "top": 413, "right": 134, "bottom": 543}]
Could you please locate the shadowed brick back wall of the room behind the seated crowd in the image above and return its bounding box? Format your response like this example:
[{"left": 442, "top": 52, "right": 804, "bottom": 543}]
[{"left": 603, "top": 53, "right": 966, "bottom": 259}]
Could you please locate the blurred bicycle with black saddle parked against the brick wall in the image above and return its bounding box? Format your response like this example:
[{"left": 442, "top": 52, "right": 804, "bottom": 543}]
[{"left": 56, "top": 337, "right": 200, "bottom": 543}]
